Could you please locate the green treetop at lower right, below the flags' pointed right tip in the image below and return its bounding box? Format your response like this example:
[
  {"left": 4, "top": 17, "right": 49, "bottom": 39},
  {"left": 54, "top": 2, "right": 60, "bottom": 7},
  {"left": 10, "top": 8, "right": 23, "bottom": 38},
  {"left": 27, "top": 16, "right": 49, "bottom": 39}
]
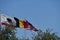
[{"left": 33, "top": 30, "right": 60, "bottom": 40}]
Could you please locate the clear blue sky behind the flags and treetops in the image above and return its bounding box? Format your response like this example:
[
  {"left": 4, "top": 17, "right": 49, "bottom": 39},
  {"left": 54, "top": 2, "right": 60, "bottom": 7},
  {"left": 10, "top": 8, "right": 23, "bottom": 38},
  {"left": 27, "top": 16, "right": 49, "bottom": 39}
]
[{"left": 0, "top": 0, "right": 60, "bottom": 36}]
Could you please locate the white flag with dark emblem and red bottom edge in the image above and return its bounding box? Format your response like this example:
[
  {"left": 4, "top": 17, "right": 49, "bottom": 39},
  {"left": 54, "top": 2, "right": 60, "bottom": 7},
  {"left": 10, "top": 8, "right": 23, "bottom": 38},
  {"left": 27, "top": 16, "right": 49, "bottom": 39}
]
[{"left": 0, "top": 14, "right": 16, "bottom": 27}]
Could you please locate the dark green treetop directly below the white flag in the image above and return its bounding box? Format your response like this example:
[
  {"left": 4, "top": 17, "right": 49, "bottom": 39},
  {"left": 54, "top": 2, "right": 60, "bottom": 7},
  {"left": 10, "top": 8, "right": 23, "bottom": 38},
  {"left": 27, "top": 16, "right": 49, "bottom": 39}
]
[{"left": 0, "top": 27, "right": 18, "bottom": 40}]
